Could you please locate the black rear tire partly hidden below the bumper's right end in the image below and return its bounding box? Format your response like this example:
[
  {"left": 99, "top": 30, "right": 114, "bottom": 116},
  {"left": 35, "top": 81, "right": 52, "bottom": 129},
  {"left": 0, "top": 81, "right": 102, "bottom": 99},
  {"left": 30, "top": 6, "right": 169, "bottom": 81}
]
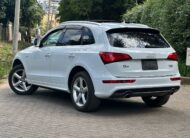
[{"left": 142, "top": 95, "right": 170, "bottom": 107}]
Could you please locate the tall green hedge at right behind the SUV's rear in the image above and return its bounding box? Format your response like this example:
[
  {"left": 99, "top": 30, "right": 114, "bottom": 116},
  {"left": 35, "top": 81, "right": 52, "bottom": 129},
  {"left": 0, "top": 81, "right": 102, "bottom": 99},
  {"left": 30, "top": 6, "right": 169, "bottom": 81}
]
[{"left": 123, "top": 0, "right": 190, "bottom": 76}]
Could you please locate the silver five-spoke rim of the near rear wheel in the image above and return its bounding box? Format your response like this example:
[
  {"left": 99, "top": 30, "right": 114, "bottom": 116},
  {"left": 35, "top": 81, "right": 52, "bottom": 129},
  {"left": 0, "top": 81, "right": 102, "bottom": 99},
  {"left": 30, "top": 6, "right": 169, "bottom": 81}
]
[{"left": 72, "top": 77, "right": 88, "bottom": 107}]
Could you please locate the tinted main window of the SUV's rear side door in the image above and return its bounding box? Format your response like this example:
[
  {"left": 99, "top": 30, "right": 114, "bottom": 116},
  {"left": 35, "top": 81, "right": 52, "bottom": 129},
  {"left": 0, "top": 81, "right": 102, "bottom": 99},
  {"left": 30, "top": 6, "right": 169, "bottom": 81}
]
[{"left": 59, "top": 29, "right": 82, "bottom": 45}]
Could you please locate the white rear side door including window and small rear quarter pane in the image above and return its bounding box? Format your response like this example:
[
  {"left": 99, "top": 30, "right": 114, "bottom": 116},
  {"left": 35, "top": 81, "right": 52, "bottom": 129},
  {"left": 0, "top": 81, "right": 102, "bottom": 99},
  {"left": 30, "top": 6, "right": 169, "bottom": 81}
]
[{"left": 51, "top": 25, "right": 95, "bottom": 88}]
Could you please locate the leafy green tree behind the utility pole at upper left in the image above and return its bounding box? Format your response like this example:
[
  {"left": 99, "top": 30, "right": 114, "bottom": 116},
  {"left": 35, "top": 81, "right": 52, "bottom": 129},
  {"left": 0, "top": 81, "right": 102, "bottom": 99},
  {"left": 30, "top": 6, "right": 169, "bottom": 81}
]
[{"left": 0, "top": 0, "right": 44, "bottom": 42}]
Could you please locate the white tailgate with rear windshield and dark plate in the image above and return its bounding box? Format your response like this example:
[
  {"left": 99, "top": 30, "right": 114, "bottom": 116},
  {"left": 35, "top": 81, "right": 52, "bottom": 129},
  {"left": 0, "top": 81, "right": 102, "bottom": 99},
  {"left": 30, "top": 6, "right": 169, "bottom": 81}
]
[{"left": 106, "top": 28, "right": 178, "bottom": 77}]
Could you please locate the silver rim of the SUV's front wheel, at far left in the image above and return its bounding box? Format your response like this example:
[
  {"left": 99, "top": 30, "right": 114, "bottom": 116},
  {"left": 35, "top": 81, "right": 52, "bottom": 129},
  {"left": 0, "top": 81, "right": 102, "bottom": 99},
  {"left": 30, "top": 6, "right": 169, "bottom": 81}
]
[{"left": 12, "top": 69, "right": 32, "bottom": 92}]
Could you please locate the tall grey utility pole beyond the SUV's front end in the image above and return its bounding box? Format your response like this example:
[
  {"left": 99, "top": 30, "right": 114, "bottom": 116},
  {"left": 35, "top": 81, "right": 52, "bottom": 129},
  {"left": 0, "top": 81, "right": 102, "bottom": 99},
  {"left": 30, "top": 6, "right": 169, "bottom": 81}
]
[{"left": 13, "top": 0, "right": 20, "bottom": 55}]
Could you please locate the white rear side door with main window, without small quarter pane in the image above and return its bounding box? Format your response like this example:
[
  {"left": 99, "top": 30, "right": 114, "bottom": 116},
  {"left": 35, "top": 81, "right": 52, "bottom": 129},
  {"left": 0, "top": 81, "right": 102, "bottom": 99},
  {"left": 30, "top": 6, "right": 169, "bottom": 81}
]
[{"left": 51, "top": 25, "right": 82, "bottom": 88}]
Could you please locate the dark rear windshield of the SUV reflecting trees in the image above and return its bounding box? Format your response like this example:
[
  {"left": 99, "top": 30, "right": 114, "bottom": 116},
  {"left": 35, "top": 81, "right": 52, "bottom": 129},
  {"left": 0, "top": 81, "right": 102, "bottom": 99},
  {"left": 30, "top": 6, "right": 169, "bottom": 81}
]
[{"left": 107, "top": 29, "right": 169, "bottom": 48}]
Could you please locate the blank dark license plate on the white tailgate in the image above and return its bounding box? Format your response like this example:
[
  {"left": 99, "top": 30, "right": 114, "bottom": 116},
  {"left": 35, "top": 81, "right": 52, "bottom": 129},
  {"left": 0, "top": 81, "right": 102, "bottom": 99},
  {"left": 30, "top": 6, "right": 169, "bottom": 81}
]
[{"left": 142, "top": 59, "right": 158, "bottom": 70}]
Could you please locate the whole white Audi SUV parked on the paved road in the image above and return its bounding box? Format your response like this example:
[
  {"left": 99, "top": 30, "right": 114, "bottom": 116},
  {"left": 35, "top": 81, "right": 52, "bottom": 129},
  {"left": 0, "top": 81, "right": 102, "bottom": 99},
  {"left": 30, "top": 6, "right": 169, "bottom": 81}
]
[{"left": 9, "top": 21, "right": 180, "bottom": 112}]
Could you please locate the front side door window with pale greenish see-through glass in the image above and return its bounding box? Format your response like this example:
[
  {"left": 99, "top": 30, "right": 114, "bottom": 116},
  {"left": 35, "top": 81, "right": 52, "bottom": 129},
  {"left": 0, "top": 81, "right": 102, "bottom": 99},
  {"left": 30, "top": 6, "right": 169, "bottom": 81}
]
[{"left": 41, "top": 30, "right": 63, "bottom": 47}]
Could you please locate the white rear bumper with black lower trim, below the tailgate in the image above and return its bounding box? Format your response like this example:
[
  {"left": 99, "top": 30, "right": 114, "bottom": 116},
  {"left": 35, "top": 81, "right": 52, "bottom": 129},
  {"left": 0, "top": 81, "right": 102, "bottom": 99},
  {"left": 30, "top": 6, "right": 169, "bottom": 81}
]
[{"left": 93, "top": 75, "right": 181, "bottom": 98}]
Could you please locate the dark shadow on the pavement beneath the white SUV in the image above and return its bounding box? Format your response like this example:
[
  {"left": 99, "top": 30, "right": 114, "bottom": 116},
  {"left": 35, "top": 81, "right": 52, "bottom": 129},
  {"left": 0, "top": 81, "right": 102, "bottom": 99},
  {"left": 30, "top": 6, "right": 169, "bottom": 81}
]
[{"left": 17, "top": 89, "right": 181, "bottom": 117}]
